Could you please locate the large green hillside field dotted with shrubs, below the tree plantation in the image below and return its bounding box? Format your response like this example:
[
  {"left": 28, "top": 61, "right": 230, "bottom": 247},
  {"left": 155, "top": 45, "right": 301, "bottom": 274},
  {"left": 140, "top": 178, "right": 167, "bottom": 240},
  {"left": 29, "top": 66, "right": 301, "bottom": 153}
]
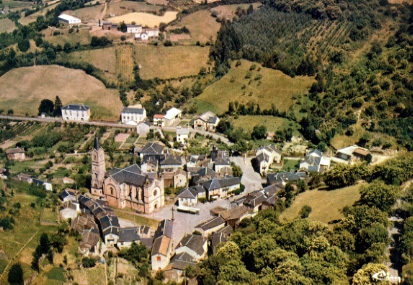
[{"left": 192, "top": 60, "right": 314, "bottom": 113}]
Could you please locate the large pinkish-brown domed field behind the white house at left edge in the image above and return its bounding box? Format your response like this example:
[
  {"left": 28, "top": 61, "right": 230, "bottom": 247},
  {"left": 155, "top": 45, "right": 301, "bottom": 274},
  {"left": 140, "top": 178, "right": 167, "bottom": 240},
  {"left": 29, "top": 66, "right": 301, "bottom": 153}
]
[{"left": 0, "top": 65, "right": 122, "bottom": 120}]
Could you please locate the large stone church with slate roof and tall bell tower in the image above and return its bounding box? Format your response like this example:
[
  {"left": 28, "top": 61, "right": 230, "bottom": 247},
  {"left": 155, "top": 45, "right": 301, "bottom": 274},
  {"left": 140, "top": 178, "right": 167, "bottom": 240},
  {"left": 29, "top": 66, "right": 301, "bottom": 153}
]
[{"left": 91, "top": 136, "right": 165, "bottom": 213}]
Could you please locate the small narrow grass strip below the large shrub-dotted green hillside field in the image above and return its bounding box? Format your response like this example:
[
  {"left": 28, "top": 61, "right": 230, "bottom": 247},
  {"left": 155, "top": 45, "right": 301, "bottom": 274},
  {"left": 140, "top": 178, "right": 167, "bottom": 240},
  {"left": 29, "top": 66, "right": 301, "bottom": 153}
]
[{"left": 232, "top": 116, "right": 296, "bottom": 132}]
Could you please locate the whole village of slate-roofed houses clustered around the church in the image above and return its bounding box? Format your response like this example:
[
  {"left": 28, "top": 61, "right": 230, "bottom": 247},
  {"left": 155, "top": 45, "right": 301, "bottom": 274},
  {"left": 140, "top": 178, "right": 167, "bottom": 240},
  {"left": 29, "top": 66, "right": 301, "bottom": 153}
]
[{"left": 2, "top": 100, "right": 373, "bottom": 282}]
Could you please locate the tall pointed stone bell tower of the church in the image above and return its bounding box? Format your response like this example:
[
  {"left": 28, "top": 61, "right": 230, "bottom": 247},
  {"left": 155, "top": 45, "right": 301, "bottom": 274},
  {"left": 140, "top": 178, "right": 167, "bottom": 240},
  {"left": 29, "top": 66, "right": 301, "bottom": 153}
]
[{"left": 91, "top": 135, "right": 106, "bottom": 196}]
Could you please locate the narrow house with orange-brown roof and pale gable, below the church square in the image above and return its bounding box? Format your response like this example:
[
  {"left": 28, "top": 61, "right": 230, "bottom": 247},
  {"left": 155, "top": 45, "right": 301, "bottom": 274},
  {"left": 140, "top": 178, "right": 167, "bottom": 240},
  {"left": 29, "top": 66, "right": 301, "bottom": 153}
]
[{"left": 151, "top": 220, "right": 173, "bottom": 270}]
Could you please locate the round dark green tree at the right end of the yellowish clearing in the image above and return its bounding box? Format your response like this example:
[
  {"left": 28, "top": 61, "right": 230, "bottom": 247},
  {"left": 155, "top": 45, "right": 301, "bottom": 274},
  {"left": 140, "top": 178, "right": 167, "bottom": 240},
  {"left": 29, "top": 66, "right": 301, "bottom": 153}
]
[{"left": 360, "top": 180, "right": 399, "bottom": 212}]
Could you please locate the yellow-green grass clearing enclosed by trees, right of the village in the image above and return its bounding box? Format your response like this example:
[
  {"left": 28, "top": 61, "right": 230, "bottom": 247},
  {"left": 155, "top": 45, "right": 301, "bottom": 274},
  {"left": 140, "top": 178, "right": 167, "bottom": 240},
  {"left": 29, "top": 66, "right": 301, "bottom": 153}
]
[{"left": 280, "top": 184, "right": 361, "bottom": 223}]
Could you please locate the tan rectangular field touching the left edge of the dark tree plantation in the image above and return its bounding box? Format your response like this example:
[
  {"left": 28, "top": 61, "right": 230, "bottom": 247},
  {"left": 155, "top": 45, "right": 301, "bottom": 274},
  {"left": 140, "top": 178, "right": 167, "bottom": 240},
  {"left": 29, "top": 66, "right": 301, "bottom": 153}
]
[{"left": 134, "top": 45, "right": 209, "bottom": 79}]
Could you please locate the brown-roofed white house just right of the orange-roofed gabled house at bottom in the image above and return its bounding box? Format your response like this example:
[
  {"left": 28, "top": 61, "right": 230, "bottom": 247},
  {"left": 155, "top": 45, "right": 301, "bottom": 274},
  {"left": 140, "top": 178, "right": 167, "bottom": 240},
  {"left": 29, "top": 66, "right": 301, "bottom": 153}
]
[{"left": 175, "top": 234, "right": 208, "bottom": 261}]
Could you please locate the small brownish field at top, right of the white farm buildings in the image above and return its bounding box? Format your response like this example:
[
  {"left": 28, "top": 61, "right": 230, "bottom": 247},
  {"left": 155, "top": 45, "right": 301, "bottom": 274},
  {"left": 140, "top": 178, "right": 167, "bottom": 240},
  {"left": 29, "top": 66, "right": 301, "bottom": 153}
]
[{"left": 168, "top": 10, "right": 221, "bottom": 43}]
